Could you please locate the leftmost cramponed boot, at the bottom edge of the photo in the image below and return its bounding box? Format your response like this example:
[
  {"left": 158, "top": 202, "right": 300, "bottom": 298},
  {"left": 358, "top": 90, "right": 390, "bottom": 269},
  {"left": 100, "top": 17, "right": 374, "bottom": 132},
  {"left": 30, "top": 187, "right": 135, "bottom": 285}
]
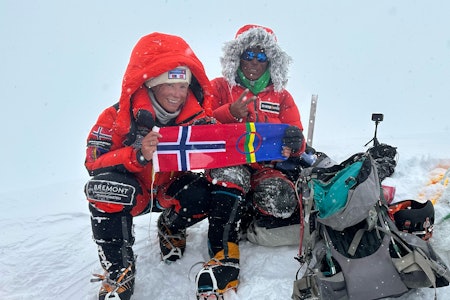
[{"left": 91, "top": 265, "right": 135, "bottom": 300}]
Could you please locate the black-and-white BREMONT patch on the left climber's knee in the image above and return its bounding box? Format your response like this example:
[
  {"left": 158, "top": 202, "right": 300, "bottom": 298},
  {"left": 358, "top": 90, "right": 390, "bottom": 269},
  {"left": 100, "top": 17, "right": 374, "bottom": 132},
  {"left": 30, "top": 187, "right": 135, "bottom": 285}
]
[{"left": 86, "top": 180, "right": 136, "bottom": 205}]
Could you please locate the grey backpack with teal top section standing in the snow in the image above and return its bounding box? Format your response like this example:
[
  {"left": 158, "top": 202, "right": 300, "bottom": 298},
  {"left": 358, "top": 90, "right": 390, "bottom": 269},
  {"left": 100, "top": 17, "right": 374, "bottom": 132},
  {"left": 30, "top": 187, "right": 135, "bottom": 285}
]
[{"left": 292, "top": 153, "right": 450, "bottom": 300}]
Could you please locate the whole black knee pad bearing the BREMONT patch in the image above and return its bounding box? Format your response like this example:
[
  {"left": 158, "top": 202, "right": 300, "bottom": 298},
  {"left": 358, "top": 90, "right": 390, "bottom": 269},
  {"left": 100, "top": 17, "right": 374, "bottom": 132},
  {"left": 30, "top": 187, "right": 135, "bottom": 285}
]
[{"left": 84, "top": 172, "right": 142, "bottom": 211}]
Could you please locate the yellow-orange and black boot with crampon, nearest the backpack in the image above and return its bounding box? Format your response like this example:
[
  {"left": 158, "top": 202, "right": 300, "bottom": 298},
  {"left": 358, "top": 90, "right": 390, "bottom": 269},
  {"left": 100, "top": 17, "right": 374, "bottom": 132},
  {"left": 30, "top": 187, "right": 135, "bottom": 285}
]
[{"left": 195, "top": 242, "right": 239, "bottom": 299}]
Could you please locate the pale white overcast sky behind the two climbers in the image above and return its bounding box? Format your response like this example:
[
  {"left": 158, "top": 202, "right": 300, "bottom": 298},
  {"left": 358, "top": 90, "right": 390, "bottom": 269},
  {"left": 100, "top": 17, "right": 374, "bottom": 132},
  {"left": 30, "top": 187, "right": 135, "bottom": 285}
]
[{"left": 0, "top": 0, "right": 450, "bottom": 189}]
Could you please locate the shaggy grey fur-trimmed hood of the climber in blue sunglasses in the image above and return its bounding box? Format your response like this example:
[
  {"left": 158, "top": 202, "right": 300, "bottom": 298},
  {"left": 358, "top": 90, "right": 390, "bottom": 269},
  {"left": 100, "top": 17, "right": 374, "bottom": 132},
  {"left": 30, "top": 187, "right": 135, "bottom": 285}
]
[{"left": 220, "top": 25, "right": 292, "bottom": 92}]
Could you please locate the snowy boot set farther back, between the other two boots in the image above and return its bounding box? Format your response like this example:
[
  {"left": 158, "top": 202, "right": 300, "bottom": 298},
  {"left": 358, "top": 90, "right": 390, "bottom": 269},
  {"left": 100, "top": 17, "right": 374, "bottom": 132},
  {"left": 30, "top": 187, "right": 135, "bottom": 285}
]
[{"left": 158, "top": 212, "right": 186, "bottom": 263}]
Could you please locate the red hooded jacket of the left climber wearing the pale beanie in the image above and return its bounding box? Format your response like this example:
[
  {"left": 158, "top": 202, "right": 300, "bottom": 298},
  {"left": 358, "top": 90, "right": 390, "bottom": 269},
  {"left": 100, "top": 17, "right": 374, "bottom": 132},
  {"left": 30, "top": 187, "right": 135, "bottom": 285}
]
[{"left": 85, "top": 33, "right": 211, "bottom": 211}]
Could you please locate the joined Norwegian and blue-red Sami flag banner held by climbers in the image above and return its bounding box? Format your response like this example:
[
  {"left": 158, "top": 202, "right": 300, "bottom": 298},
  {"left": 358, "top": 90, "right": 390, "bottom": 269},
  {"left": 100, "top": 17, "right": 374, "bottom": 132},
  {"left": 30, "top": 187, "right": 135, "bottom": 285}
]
[{"left": 153, "top": 123, "right": 289, "bottom": 172}]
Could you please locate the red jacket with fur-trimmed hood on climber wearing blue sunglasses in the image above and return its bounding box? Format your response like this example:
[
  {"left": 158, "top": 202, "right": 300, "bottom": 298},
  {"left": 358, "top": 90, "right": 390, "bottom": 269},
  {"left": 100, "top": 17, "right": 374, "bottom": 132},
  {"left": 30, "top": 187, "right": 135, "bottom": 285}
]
[{"left": 211, "top": 25, "right": 306, "bottom": 153}]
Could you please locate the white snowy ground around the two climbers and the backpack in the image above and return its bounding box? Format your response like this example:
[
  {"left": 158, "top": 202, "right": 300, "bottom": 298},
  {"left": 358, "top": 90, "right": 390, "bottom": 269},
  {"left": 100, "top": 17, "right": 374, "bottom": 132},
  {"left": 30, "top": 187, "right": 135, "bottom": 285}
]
[{"left": 0, "top": 138, "right": 450, "bottom": 300}]
